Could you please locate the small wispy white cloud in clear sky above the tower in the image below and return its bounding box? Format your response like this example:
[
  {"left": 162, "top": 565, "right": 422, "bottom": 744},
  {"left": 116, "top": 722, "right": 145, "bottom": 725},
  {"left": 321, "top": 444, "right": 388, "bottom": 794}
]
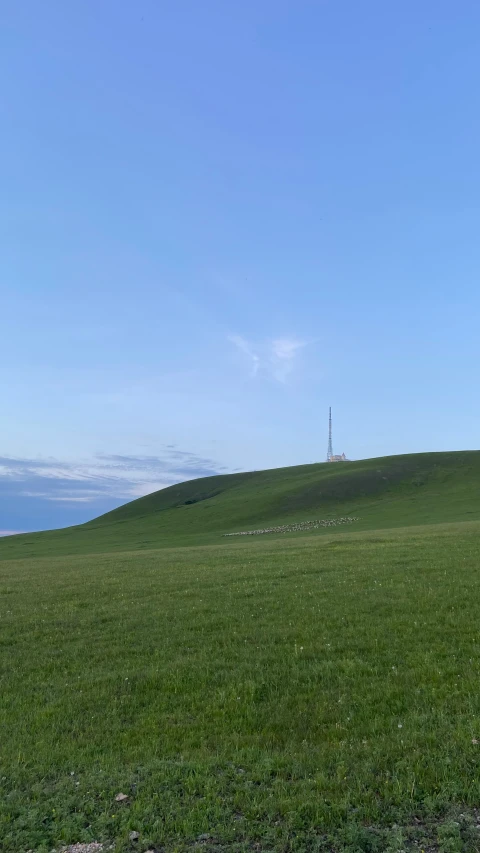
[{"left": 229, "top": 335, "right": 307, "bottom": 382}]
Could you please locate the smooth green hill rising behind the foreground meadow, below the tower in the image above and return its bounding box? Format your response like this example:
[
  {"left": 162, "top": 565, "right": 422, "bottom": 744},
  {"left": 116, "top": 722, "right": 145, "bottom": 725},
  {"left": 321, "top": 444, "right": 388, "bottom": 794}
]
[{"left": 0, "top": 451, "right": 480, "bottom": 559}]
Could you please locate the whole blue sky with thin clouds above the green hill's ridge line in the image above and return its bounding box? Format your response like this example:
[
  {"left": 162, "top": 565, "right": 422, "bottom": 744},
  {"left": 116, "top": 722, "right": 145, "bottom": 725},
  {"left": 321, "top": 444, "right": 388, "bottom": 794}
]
[{"left": 0, "top": 0, "right": 480, "bottom": 531}]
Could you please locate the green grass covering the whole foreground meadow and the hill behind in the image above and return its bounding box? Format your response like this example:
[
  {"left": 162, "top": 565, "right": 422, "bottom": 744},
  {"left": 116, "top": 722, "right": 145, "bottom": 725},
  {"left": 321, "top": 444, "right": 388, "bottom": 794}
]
[{"left": 0, "top": 453, "right": 480, "bottom": 853}]
